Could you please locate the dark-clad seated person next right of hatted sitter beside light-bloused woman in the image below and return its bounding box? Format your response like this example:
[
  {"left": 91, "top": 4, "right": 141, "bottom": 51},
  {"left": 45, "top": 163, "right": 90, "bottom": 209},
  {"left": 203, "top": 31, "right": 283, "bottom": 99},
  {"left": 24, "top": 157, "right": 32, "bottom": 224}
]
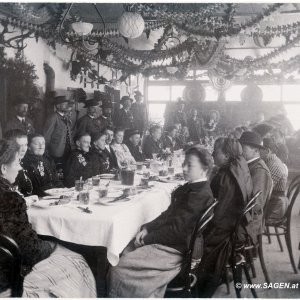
[{"left": 143, "top": 125, "right": 163, "bottom": 159}]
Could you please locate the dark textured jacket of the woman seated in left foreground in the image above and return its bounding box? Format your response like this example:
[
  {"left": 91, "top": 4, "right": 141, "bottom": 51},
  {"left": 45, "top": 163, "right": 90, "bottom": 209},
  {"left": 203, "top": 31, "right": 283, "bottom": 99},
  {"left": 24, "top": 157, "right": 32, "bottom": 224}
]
[{"left": 0, "top": 177, "right": 53, "bottom": 290}]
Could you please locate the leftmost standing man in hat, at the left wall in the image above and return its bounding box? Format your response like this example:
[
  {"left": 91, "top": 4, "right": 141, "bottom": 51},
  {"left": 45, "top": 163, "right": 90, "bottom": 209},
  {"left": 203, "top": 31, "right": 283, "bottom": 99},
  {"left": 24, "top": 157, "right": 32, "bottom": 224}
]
[{"left": 5, "top": 95, "right": 35, "bottom": 135}]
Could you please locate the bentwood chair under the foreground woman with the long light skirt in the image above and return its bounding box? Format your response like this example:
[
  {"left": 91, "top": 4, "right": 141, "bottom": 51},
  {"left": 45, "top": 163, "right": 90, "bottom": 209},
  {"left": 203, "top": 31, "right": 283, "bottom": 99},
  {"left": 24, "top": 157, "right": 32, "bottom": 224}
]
[{"left": 165, "top": 201, "right": 218, "bottom": 298}]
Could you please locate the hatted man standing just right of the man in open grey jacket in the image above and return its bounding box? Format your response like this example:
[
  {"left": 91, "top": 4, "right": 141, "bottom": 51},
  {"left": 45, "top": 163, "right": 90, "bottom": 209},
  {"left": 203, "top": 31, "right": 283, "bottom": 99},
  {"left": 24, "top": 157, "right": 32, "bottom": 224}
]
[{"left": 76, "top": 99, "right": 105, "bottom": 136}]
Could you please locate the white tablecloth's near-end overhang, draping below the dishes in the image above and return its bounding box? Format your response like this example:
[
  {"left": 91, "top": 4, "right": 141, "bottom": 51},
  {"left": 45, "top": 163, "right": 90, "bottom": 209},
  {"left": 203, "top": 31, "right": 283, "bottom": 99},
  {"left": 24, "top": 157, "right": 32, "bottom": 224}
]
[{"left": 28, "top": 177, "right": 178, "bottom": 266}]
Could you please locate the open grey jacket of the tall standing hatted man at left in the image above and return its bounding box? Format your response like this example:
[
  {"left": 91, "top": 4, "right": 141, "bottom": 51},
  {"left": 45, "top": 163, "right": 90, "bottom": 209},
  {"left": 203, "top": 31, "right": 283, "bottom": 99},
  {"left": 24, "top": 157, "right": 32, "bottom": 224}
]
[{"left": 44, "top": 112, "right": 74, "bottom": 158}]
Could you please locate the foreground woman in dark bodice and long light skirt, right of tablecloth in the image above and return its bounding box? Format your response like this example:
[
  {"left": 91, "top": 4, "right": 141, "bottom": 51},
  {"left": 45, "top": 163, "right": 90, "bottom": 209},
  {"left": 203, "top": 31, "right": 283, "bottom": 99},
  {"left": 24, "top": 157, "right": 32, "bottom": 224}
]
[{"left": 108, "top": 147, "right": 214, "bottom": 298}]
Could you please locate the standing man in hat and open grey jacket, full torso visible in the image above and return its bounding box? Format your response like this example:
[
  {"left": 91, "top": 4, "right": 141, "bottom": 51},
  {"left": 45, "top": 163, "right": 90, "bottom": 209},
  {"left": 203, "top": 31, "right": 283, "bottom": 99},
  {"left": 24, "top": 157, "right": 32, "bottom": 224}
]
[{"left": 44, "top": 96, "right": 73, "bottom": 168}]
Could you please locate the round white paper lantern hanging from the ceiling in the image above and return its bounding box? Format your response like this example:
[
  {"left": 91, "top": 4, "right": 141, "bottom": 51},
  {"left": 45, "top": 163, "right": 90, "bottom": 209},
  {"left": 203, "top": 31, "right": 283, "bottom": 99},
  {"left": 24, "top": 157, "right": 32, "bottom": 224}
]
[{"left": 118, "top": 12, "right": 145, "bottom": 39}]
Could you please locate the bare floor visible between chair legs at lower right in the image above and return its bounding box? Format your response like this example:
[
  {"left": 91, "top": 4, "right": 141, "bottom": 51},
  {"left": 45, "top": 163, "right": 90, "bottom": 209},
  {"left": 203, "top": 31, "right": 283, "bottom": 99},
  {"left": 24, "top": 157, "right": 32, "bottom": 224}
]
[{"left": 214, "top": 191, "right": 300, "bottom": 299}]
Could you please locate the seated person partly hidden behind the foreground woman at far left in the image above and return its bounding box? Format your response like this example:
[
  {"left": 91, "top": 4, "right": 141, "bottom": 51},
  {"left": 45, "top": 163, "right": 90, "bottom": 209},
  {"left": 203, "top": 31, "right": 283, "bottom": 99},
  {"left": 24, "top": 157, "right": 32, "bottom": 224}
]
[{"left": 4, "top": 129, "right": 33, "bottom": 197}]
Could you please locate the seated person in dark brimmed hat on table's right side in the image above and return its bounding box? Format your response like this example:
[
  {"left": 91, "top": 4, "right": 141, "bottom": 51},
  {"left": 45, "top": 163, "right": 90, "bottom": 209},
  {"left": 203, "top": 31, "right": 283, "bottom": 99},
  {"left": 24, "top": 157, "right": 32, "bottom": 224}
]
[{"left": 239, "top": 131, "right": 273, "bottom": 243}]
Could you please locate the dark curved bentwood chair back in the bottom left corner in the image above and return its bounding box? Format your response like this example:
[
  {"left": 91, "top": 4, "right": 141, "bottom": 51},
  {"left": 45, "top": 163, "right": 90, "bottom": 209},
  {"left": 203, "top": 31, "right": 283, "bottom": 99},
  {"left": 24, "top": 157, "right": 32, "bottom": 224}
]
[{"left": 0, "top": 234, "right": 24, "bottom": 298}]
